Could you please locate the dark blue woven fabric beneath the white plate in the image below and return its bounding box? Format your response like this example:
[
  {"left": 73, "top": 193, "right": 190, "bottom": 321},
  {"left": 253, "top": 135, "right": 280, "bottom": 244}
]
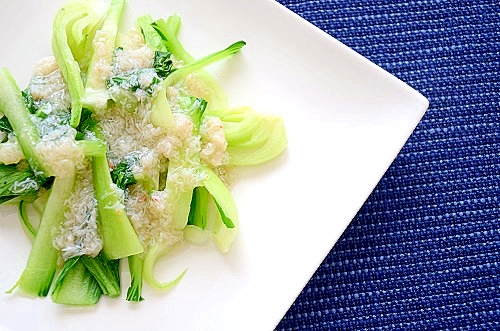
[{"left": 277, "top": 0, "right": 500, "bottom": 330}]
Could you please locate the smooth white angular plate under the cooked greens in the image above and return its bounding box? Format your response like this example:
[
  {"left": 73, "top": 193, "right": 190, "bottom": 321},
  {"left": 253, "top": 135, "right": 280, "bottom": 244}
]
[{"left": 0, "top": 0, "right": 428, "bottom": 331}]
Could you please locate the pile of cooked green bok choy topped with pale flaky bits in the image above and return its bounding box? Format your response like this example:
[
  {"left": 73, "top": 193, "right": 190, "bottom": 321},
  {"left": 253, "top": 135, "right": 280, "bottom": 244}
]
[{"left": 0, "top": 0, "right": 287, "bottom": 305}]
